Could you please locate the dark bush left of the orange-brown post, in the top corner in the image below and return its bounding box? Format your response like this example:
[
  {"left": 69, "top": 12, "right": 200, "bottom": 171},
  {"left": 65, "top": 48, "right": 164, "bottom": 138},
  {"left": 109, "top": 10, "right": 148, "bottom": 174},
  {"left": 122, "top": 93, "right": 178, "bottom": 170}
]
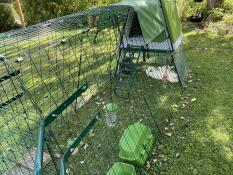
[{"left": 0, "top": 3, "right": 15, "bottom": 32}]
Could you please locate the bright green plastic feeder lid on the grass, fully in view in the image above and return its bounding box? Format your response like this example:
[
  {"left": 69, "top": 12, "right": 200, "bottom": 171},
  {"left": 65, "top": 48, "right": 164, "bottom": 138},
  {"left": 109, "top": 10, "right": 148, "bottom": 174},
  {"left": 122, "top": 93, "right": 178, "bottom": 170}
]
[{"left": 119, "top": 123, "right": 155, "bottom": 166}]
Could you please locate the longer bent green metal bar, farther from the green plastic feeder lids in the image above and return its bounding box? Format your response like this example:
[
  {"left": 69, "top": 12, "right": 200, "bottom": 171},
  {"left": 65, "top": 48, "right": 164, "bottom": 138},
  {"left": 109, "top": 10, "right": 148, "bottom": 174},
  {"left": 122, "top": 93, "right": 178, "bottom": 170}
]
[{"left": 34, "top": 83, "right": 88, "bottom": 175}]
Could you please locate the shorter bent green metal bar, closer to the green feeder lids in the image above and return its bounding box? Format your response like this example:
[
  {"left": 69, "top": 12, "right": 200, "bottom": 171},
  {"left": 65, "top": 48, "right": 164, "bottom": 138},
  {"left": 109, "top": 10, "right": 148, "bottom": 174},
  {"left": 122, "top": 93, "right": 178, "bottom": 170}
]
[{"left": 60, "top": 112, "right": 100, "bottom": 175}]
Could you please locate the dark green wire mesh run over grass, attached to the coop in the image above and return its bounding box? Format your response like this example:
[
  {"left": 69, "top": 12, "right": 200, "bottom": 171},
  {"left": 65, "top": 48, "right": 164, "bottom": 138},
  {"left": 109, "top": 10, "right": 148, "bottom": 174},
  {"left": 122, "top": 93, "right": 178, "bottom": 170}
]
[{"left": 0, "top": 2, "right": 184, "bottom": 174}]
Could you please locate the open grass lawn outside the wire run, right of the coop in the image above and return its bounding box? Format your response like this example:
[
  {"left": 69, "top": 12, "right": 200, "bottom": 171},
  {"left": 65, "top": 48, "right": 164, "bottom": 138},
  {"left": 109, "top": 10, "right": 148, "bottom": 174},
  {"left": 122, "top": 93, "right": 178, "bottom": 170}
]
[{"left": 147, "top": 15, "right": 233, "bottom": 175}]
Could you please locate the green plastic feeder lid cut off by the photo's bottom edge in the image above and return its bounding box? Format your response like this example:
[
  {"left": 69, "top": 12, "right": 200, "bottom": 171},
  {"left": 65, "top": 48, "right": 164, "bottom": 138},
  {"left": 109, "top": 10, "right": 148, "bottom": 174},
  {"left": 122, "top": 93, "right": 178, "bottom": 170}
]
[{"left": 107, "top": 163, "right": 137, "bottom": 175}]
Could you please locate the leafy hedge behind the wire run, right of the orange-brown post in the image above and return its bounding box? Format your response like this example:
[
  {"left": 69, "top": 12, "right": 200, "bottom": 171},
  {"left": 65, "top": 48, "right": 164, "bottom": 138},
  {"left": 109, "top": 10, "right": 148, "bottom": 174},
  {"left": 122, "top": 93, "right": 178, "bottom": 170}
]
[{"left": 22, "top": 0, "right": 119, "bottom": 24}]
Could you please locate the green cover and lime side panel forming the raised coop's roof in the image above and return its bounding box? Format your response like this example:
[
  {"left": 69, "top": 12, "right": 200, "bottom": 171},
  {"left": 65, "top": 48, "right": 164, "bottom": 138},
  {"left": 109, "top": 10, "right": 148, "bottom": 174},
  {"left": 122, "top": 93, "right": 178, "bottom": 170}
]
[{"left": 116, "top": 0, "right": 182, "bottom": 43}]
